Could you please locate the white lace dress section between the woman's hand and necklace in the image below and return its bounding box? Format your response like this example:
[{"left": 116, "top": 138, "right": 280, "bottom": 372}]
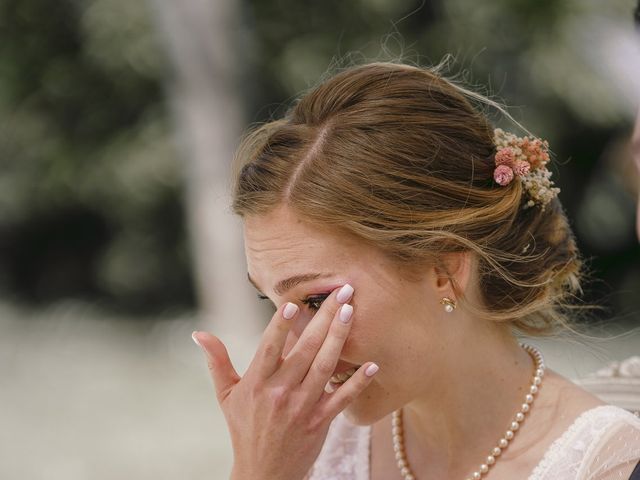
[{"left": 307, "top": 413, "right": 371, "bottom": 480}]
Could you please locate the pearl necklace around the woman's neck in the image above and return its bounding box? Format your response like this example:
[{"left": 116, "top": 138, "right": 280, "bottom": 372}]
[{"left": 391, "top": 343, "right": 545, "bottom": 480}]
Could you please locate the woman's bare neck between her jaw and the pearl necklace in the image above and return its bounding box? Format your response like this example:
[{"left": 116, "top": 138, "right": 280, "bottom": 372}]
[{"left": 403, "top": 326, "right": 534, "bottom": 478}]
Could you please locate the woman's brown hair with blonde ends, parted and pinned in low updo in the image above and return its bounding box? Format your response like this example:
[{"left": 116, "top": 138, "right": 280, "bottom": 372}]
[{"left": 233, "top": 63, "right": 582, "bottom": 335}]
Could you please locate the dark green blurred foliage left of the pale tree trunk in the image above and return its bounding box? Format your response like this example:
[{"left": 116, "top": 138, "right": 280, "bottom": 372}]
[{"left": 0, "top": 0, "right": 193, "bottom": 310}]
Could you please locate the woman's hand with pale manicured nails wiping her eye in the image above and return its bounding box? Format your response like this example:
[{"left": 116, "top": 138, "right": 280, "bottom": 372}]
[{"left": 193, "top": 285, "right": 378, "bottom": 480}]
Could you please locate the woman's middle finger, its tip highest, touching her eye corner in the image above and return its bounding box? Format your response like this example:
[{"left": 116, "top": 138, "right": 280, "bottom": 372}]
[{"left": 281, "top": 283, "right": 353, "bottom": 383}]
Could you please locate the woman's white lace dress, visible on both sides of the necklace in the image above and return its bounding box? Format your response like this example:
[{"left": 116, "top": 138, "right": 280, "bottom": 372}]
[{"left": 307, "top": 405, "right": 640, "bottom": 480}]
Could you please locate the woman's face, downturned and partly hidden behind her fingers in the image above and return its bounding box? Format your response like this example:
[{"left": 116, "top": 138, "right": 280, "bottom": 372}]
[{"left": 244, "top": 203, "right": 450, "bottom": 425}]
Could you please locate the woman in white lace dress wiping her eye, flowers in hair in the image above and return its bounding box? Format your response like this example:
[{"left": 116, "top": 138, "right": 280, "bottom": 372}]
[{"left": 194, "top": 63, "right": 640, "bottom": 480}]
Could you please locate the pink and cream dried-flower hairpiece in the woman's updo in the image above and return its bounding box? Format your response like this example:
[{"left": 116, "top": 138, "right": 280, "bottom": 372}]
[{"left": 493, "top": 128, "right": 560, "bottom": 210}]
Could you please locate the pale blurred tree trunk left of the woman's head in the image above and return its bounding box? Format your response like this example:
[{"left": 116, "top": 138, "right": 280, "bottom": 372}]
[{"left": 151, "top": 0, "right": 262, "bottom": 334}]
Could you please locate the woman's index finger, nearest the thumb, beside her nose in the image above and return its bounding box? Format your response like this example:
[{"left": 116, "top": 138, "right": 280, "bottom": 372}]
[{"left": 247, "top": 302, "right": 300, "bottom": 378}]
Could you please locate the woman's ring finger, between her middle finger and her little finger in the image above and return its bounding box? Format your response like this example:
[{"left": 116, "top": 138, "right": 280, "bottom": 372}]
[{"left": 302, "top": 303, "right": 353, "bottom": 403}]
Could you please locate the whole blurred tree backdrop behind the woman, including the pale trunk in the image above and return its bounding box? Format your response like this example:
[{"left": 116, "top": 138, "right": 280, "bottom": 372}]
[{"left": 0, "top": 0, "right": 640, "bottom": 324}]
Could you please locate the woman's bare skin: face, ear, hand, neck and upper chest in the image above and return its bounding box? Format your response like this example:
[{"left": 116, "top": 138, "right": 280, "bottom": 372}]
[{"left": 195, "top": 206, "right": 602, "bottom": 480}]
